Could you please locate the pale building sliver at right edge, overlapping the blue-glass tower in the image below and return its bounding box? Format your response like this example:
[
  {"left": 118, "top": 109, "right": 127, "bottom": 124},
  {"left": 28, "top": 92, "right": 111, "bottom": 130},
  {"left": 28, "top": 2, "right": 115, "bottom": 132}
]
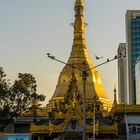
[{"left": 135, "top": 56, "right": 140, "bottom": 104}]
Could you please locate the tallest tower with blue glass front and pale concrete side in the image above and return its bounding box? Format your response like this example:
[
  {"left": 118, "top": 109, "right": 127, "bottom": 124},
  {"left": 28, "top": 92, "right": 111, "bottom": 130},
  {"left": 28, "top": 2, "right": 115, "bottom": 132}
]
[{"left": 126, "top": 10, "right": 140, "bottom": 104}]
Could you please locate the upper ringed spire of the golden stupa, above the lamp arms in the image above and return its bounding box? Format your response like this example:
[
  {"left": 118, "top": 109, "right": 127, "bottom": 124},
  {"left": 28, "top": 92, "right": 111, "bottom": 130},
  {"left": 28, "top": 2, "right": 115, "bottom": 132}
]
[{"left": 68, "top": 0, "right": 89, "bottom": 64}]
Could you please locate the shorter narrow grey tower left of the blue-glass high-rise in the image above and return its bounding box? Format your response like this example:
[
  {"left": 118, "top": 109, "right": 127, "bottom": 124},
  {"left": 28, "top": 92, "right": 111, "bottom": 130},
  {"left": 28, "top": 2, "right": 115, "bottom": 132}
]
[{"left": 118, "top": 43, "right": 127, "bottom": 104}]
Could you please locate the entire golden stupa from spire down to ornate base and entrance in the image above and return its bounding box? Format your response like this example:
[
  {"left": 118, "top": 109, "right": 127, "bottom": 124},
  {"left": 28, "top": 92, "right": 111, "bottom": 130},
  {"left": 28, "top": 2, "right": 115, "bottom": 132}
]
[{"left": 30, "top": 0, "right": 118, "bottom": 140}]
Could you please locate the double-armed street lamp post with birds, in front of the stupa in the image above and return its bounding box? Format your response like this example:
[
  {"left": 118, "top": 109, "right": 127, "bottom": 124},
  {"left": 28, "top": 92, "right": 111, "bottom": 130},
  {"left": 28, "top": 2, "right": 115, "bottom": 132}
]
[{"left": 47, "top": 53, "right": 122, "bottom": 140}]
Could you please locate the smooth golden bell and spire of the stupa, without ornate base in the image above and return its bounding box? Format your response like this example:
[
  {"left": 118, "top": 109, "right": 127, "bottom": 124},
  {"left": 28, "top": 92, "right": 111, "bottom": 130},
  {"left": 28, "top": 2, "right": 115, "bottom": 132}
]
[{"left": 47, "top": 0, "right": 112, "bottom": 111}]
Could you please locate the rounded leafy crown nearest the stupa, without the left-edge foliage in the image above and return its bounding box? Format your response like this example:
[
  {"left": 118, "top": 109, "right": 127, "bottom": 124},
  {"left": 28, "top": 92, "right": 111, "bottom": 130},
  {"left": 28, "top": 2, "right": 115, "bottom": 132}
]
[{"left": 10, "top": 73, "right": 45, "bottom": 114}]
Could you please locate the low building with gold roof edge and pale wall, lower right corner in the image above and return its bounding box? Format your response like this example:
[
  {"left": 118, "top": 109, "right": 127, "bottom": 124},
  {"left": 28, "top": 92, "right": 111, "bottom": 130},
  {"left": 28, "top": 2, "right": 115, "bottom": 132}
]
[{"left": 112, "top": 104, "right": 140, "bottom": 140}]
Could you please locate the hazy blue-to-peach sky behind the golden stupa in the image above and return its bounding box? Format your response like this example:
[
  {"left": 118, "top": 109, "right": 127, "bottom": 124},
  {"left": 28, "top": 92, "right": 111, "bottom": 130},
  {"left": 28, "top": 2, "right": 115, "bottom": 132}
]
[{"left": 0, "top": 0, "right": 140, "bottom": 102}]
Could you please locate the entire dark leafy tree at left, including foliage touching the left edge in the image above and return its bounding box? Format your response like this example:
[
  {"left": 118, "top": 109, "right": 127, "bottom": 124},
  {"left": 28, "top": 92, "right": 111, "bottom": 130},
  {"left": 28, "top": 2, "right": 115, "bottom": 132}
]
[{"left": 0, "top": 68, "right": 45, "bottom": 130}]
